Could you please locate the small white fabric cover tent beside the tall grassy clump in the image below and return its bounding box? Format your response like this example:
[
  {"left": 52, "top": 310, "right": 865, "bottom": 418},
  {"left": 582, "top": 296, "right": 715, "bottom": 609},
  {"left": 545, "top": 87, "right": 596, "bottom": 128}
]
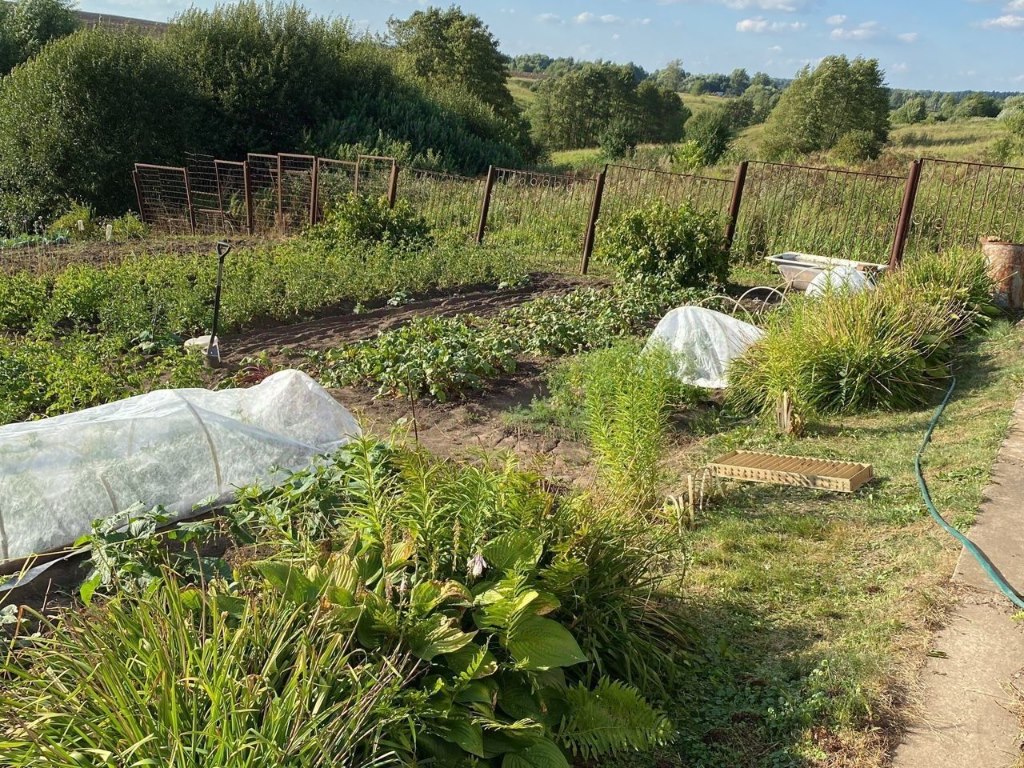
[{"left": 647, "top": 306, "right": 764, "bottom": 389}]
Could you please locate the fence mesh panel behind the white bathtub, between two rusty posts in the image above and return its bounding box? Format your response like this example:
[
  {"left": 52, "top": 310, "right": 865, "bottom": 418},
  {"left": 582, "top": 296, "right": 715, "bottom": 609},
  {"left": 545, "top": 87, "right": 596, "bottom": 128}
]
[{"left": 733, "top": 162, "right": 906, "bottom": 263}]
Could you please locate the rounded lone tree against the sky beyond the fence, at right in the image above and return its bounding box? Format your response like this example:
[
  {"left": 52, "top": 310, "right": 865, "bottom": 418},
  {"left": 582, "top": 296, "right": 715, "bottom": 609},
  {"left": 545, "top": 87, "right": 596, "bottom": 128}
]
[{"left": 763, "top": 56, "right": 889, "bottom": 158}]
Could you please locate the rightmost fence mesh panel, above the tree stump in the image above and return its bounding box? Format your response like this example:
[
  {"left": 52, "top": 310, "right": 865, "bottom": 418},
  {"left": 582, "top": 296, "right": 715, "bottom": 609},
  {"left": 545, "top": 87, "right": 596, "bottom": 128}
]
[{"left": 907, "top": 159, "right": 1024, "bottom": 253}]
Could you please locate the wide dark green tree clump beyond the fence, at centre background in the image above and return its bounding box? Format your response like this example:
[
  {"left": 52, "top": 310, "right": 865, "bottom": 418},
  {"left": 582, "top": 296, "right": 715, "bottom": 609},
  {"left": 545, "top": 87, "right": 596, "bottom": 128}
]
[{"left": 530, "top": 63, "right": 689, "bottom": 150}]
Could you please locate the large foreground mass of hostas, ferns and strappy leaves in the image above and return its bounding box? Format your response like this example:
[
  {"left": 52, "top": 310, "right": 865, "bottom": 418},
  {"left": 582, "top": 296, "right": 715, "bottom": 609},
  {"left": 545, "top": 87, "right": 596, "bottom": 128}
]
[{"left": 19, "top": 439, "right": 690, "bottom": 768}]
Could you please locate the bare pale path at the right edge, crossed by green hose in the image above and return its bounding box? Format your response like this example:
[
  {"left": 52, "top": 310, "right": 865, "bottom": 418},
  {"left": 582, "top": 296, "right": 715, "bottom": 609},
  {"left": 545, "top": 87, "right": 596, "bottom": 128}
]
[{"left": 893, "top": 397, "right": 1024, "bottom": 768}]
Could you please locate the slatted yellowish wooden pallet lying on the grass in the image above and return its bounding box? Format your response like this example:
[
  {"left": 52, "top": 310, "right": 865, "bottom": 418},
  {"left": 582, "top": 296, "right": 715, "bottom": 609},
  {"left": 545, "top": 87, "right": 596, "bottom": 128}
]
[{"left": 708, "top": 451, "right": 874, "bottom": 494}]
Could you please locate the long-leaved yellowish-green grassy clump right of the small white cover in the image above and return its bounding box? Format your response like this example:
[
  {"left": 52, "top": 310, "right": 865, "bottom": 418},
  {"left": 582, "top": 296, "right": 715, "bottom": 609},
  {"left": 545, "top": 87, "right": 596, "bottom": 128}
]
[{"left": 729, "top": 260, "right": 991, "bottom": 417}]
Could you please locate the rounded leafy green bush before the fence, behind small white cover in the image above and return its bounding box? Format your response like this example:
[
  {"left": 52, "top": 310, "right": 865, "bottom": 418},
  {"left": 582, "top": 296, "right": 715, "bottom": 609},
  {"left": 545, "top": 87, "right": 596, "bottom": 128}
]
[{"left": 600, "top": 201, "right": 729, "bottom": 288}]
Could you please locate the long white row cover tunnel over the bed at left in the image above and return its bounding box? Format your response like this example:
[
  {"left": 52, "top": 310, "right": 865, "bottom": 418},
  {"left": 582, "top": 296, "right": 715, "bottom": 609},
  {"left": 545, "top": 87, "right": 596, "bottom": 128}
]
[{"left": 0, "top": 371, "right": 359, "bottom": 560}]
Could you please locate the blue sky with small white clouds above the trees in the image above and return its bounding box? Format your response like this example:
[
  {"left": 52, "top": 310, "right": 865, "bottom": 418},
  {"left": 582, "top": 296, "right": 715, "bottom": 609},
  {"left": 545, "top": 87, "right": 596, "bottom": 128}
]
[{"left": 81, "top": 0, "right": 1024, "bottom": 90}]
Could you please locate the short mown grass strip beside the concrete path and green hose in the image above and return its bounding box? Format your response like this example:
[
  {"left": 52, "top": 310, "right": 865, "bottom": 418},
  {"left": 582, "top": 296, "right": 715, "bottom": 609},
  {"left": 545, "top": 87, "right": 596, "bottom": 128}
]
[{"left": 658, "top": 323, "right": 1024, "bottom": 767}]
